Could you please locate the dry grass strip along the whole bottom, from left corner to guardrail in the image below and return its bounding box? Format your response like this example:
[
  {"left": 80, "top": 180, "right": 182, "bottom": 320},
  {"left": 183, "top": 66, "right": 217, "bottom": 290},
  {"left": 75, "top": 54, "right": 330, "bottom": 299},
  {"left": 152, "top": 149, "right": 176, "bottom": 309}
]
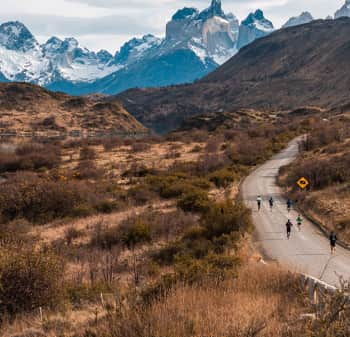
[{"left": 1, "top": 263, "right": 305, "bottom": 337}]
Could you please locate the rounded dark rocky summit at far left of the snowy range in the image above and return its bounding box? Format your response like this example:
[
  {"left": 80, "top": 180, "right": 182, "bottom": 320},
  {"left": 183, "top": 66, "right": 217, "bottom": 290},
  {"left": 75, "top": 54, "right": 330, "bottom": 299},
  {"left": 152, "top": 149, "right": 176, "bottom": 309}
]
[{"left": 0, "top": 21, "right": 39, "bottom": 51}]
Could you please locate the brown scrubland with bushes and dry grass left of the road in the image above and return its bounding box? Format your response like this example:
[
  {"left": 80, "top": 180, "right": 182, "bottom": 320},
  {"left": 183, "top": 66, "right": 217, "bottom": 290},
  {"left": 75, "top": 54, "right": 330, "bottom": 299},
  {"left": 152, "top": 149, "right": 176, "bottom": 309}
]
[{"left": 0, "top": 114, "right": 348, "bottom": 337}]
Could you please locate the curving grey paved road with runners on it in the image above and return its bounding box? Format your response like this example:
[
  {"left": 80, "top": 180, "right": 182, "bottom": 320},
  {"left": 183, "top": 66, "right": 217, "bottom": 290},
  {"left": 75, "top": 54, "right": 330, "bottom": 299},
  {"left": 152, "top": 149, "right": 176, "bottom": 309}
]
[{"left": 242, "top": 136, "right": 350, "bottom": 286}]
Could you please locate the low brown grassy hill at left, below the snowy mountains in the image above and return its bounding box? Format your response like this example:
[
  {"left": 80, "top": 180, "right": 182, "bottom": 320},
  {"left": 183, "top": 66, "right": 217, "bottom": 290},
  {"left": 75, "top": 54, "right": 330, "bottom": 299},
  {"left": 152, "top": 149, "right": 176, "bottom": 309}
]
[{"left": 0, "top": 83, "right": 147, "bottom": 135}]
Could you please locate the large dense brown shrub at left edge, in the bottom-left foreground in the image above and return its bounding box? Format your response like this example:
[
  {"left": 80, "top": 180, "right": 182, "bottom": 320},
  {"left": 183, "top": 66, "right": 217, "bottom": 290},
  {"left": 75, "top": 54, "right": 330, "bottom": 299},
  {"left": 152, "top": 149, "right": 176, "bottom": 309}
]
[{"left": 0, "top": 250, "right": 64, "bottom": 314}]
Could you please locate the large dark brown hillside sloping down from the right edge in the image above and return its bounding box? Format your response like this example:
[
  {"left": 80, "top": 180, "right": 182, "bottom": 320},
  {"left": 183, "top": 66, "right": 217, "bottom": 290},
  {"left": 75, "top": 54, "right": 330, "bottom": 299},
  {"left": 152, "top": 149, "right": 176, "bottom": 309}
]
[{"left": 117, "top": 18, "right": 350, "bottom": 132}]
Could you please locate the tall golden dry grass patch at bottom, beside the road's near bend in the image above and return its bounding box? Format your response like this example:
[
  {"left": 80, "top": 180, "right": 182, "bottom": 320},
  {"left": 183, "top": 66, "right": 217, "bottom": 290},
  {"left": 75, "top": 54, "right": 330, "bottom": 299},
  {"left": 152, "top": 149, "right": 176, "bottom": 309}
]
[{"left": 77, "top": 264, "right": 304, "bottom": 337}]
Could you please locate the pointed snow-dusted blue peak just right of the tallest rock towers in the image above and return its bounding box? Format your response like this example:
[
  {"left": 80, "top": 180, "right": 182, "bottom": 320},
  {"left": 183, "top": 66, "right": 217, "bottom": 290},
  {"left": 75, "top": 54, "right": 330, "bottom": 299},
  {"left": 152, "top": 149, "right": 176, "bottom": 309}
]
[{"left": 237, "top": 9, "right": 274, "bottom": 49}]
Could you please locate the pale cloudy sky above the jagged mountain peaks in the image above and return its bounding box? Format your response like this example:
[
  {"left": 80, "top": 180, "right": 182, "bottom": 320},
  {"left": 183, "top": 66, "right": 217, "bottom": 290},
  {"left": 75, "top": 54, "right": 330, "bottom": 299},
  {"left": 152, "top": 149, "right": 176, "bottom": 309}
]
[{"left": 0, "top": 0, "right": 345, "bottom": 53}]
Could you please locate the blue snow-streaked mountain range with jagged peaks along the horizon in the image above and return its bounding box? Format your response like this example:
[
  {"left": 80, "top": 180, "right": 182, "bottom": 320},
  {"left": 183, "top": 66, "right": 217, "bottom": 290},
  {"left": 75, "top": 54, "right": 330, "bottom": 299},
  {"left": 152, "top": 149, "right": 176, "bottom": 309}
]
[{"left": 0, "top": 0, "right": 350, "bottom": 95}]
